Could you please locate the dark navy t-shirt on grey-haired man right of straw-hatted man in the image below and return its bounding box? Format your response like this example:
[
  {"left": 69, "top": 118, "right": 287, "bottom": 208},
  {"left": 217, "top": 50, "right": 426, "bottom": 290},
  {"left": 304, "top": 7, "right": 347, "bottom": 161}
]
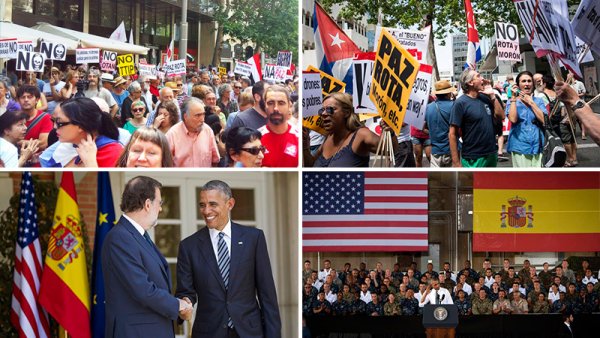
[{"left": 450, "top": 94, "right": 497, "bottom": 160}]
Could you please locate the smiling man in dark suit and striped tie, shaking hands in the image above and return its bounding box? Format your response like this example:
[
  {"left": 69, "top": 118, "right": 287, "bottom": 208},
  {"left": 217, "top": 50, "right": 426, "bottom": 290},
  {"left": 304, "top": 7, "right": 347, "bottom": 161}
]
[{"left": 175, "top": 181, "right": 281, "bottom": 338}]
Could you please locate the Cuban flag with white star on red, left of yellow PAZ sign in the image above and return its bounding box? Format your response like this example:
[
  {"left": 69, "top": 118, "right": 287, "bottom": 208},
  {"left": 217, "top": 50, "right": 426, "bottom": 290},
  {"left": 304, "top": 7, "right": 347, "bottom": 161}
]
[{"left": 313, "top": 2, "right": 362, "bottom": 94}]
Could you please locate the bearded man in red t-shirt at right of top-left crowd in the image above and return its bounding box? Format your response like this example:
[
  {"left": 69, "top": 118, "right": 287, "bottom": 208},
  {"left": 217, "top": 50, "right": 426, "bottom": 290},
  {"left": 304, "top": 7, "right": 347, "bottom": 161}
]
[{"left": 258, "top": 85, "right": 299, "bottom": 168}]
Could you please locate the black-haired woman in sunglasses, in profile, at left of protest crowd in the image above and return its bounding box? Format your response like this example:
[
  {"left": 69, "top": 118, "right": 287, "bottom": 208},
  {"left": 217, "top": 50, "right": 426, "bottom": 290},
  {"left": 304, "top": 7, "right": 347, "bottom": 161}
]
[{"left": 53, "top": 97, "right": 123, "bottom": 168}]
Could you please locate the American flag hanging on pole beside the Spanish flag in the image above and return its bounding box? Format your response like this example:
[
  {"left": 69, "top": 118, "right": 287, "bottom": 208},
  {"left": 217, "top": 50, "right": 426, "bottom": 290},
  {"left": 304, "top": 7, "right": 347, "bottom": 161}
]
[{"left": 10, "top": 172, "right": 50, "bottom": 338}]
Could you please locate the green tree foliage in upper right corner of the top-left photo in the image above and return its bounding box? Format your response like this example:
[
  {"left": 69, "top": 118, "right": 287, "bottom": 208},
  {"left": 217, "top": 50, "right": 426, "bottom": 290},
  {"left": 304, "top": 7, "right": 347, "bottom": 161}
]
[{"left": 215, "top": 0, "right": 299, "bottom": 60}]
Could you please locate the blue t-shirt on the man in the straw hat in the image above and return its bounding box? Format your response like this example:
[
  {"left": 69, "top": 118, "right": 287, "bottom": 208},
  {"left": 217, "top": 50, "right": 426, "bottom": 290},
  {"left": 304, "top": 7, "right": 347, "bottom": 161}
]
[{"left": 425, "top": 100, "right": 454, "bottom": 155}]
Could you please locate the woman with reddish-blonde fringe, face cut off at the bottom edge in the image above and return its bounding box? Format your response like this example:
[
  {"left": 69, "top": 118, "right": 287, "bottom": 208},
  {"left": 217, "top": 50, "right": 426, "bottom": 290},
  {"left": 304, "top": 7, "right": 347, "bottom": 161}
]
[{"left": 116, "top": 127, "right": 173, "bottom": 168}]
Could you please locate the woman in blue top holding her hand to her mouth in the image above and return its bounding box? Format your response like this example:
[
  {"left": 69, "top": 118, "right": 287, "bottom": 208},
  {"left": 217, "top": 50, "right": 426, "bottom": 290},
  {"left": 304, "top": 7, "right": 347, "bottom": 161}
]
[{"left": 506, "top": 71, "right": 548, "bottom": 168}]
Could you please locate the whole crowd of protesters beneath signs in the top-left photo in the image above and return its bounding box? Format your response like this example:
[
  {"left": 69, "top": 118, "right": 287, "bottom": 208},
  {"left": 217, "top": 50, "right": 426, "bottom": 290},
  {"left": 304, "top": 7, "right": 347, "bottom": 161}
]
[{"left": 0, "top": 64, "right": 299, "bottom": 168}]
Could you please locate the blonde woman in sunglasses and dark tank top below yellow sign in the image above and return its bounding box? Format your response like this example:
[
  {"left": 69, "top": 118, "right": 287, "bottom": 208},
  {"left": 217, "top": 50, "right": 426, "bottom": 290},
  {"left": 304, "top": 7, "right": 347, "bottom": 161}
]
[{"left": 303, "top": 93, "right": 398, "bottom": 167}]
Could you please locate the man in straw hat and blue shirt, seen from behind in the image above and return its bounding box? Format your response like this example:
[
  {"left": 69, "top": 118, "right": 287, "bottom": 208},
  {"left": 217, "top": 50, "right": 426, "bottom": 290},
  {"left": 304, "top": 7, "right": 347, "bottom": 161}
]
[{"left": 425, "top": 80, "right": 456, "bottom": 168}]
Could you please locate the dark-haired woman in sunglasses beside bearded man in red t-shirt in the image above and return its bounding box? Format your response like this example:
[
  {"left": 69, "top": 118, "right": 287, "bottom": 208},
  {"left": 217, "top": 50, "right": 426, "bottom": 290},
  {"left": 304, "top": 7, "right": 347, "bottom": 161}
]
[{"left": 223, "top": 127, "right": 265, "bottom": 168}]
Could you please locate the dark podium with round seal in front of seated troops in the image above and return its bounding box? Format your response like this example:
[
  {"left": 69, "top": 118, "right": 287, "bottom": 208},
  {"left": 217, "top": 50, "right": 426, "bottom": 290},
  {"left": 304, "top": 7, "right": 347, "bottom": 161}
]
[{"left": 423, "top": 304, "right": 458, "bottom": 338}]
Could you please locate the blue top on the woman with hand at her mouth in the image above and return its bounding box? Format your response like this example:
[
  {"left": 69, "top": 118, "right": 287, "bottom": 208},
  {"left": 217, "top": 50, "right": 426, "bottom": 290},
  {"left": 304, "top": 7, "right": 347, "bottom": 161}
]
[{"left": 506, "top": 97, "right": 548, "bottom": 155}]
